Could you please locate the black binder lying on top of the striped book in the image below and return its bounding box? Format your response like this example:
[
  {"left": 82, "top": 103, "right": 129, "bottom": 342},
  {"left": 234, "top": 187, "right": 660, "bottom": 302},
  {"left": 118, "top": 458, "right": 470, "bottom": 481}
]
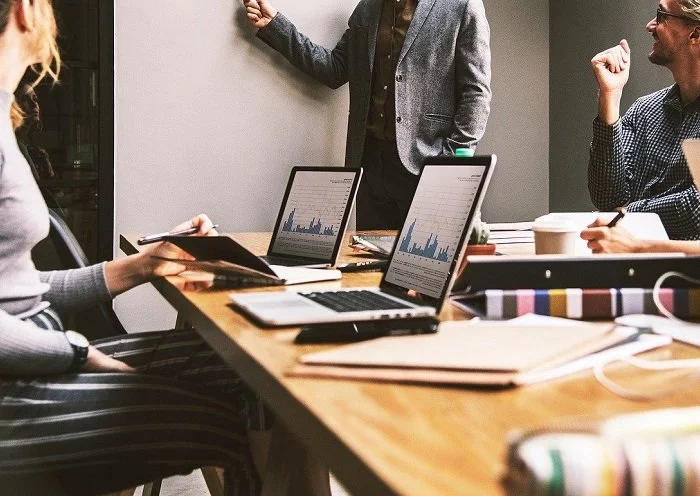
[{"left": 452, "top": 254, "right": 700, "bottom": 293}]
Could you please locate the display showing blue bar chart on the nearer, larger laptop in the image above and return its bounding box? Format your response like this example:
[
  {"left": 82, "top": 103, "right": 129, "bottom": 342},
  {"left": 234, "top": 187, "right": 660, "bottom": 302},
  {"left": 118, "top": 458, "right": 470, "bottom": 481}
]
[{"left": 384, "top": 165, "right": 486, "bottom": 298}]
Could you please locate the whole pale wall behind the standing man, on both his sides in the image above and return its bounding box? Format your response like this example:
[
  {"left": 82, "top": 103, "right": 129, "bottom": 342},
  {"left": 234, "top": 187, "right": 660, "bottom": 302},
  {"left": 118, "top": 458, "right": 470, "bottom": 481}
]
[{"left": 115, "top": 0, "right": 548, "bottom": 330}]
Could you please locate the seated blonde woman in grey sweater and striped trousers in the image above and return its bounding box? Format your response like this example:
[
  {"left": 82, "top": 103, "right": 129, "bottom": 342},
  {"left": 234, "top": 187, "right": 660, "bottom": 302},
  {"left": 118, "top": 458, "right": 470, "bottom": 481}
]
[{"left": 0, "top": 0, "right": 274, "bottom": 495}]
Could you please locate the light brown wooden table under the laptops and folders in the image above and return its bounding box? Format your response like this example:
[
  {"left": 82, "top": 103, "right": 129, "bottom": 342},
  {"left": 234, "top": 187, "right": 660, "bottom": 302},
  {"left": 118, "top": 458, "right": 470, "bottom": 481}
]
[{"left": 120, "top": 233, "right": 700, "bottom": 496}]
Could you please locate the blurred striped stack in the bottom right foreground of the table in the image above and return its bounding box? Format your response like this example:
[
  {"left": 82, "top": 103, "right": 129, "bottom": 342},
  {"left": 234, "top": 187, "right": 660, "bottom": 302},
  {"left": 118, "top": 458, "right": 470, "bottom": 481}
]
[{"left": 505, "top": 407, "right": 700, "bottom": 496}]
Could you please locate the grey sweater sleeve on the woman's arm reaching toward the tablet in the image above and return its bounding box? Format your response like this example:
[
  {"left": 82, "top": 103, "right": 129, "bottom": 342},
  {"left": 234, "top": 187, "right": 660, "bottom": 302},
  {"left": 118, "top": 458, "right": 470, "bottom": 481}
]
[{"left": 39, "top": 263, "right": 112, "bottom": 313}]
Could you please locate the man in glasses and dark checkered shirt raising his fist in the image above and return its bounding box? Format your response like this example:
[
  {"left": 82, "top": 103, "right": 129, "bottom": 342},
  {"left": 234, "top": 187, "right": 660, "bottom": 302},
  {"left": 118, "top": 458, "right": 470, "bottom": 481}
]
[{"left": 588, "top": 0, "right": 700, "bottom": 240}]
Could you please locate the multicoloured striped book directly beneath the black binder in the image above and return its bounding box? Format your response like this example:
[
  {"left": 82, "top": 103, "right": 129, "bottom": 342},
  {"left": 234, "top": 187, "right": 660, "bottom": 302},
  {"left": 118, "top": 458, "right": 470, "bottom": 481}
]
[{"left": 451, "top": 288, "right": 700, "bottom": 319}]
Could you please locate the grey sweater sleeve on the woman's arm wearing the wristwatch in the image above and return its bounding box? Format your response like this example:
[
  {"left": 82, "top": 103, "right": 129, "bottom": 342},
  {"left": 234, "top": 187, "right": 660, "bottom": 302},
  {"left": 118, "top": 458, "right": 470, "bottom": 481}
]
[{"left": 0, "top": 310, "right": 73, "bottom": 377}]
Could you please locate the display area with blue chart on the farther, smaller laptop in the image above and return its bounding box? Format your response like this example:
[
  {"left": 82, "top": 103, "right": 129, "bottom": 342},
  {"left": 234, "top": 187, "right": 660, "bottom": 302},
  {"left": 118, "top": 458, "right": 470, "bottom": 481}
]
[{"left": 270, "top": 168, "right": 356, "bottom": 259}]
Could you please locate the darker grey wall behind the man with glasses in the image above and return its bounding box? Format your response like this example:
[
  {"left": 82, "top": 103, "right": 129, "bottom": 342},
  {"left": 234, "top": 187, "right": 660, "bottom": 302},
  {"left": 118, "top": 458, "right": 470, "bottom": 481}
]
[{"left": 549, "top": 0, "right": 673, "bottom": 212}]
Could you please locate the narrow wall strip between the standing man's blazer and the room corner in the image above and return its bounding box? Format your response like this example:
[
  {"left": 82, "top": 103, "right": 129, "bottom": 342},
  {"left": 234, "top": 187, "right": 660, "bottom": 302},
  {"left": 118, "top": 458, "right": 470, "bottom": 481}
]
[{"left": 477, "top": 0, "right": 557, "bottom": 222}]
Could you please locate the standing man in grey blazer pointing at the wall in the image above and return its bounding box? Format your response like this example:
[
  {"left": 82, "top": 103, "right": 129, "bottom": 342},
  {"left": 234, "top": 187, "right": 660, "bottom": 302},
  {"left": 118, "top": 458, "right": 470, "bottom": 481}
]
[{"left": 243, "top": 0, "right": 491, "bottom": 229}]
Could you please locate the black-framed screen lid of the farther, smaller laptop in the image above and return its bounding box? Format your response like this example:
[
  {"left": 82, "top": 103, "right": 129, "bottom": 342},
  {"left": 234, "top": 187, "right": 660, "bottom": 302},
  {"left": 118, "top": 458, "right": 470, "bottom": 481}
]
[{"left": 261, "top": 167, "right": 362, "bottom": 268}]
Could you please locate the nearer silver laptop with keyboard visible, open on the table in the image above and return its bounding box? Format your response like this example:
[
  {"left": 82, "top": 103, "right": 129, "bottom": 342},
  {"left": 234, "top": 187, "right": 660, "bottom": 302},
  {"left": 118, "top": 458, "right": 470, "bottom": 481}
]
[{"left": 229, "top": 155, "right": 496, "bottom": 326}]
